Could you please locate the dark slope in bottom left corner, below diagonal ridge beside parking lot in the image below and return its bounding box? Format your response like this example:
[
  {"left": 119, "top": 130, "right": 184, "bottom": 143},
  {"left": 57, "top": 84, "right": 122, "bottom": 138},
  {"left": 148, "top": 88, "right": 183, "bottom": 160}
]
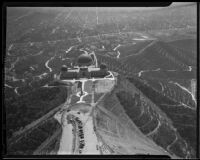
[{"left": 7, "top": 118, "right": 61, "bottom": 155}]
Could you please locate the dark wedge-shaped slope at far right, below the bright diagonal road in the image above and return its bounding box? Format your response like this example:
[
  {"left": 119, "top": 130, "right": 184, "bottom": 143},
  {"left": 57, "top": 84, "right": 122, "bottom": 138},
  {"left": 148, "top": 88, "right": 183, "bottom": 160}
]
[{"left": 127, "top": 78, "right": 196, "bottom": 158}]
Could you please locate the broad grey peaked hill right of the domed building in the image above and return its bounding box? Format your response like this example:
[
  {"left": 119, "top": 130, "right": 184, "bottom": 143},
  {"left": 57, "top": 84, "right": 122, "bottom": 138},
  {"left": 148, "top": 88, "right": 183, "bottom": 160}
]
[{"left": 120, "top": 41, "right": 196, "bottom": 72}]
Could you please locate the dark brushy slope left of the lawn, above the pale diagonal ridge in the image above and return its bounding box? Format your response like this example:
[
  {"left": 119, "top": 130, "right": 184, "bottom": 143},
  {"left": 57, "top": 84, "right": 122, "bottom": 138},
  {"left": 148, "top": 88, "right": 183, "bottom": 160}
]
[{"left": 6, "top": 87, "right": 67, "bottom": 139}]
